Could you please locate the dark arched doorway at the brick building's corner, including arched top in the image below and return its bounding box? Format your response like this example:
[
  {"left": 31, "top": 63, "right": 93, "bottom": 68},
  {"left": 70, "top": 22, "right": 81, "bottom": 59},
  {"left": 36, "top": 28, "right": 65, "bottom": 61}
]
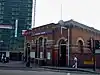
[{"left": 58, "top": 39, "right": 66, "bottom": 66}]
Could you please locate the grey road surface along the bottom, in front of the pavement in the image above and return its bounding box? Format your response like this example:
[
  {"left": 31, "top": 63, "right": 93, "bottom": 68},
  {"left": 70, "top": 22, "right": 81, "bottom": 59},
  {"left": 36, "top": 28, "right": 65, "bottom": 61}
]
[{"left": 0, "top": 70, "right": 99, "bottom": 75}]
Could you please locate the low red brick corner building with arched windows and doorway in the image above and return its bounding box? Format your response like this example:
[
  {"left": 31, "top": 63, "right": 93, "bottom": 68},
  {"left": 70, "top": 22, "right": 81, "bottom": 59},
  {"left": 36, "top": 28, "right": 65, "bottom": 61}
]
[{"left": 25, "top": 20, "right": 100, "bottom": 67}]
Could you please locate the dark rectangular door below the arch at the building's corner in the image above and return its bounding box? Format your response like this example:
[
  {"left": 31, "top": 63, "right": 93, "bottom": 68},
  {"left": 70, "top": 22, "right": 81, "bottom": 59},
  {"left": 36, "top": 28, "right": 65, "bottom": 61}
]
[{"left": 60, "top": 45, "right": 66, "bottom": 66}]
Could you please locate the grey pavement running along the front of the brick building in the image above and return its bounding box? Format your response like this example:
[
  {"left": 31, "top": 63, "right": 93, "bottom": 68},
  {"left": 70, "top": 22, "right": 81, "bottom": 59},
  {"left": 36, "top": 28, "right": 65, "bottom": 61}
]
[{"left": 0, "top": 61, "right": 100, "bottom": 74}]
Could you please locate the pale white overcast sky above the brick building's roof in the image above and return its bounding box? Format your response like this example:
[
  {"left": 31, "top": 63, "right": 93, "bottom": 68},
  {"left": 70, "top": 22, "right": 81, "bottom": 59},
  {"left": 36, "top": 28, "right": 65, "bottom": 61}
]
[{"left": 33, "top": 0, "right": 100, "bottom": 30}]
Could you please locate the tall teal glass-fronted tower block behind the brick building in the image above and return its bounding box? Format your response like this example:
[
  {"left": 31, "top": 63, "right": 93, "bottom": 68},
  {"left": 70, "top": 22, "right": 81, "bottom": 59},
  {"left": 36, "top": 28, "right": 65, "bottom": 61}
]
[{"left": 0, "top": 0, "right": 33, "bottom": 59}]
